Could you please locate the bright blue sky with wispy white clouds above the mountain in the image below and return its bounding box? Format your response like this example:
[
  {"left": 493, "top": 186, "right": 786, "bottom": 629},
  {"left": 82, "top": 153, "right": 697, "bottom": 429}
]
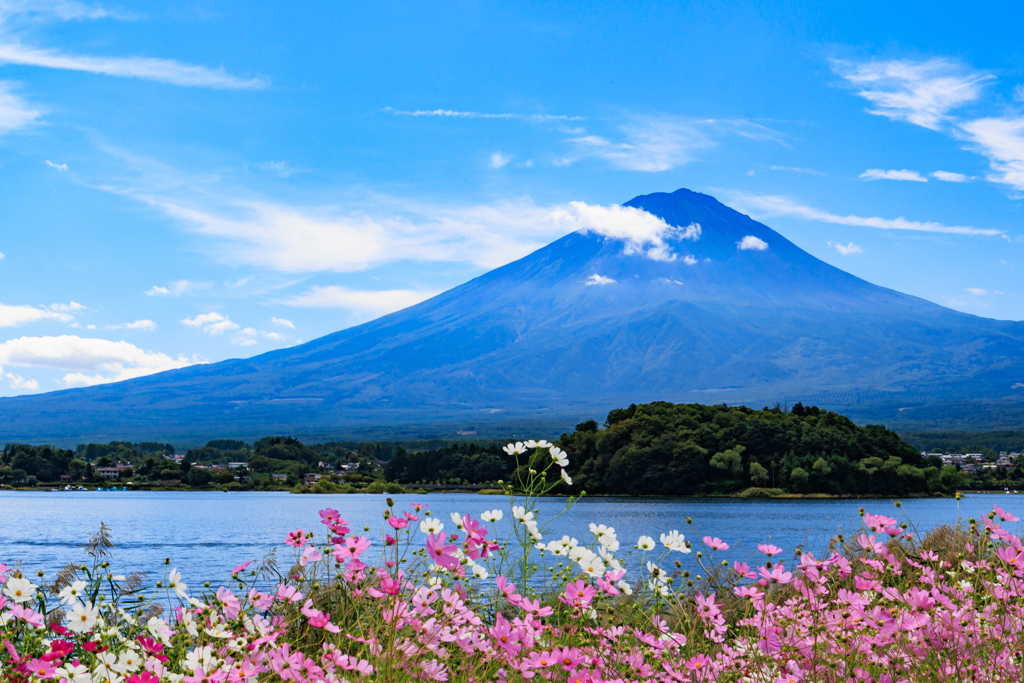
[{"left": 0, "top": 0, "right": 1024, "bottom": 395}]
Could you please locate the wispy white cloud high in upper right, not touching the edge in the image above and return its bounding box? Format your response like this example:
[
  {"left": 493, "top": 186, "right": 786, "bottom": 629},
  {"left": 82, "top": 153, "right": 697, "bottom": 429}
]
[{"left": 831, "top": 58, "right": 993, "bottom": 130}]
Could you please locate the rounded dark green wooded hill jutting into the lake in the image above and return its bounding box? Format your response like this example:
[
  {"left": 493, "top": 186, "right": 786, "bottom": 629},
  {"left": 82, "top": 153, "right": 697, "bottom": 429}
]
[{"left": 559, "top": 401, "right": 964, "bottom": 496}]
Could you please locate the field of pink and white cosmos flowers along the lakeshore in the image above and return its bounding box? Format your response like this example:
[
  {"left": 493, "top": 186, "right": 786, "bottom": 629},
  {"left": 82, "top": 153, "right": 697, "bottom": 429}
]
[{"left": 0, "top": 441, "right": 1024, "bottom": 683}]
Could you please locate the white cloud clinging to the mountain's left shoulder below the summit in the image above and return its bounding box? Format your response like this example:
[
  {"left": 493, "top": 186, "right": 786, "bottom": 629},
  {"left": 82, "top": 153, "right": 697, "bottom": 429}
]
[{"left": 554, "top": 202, "right": 700, "bottom": 261}]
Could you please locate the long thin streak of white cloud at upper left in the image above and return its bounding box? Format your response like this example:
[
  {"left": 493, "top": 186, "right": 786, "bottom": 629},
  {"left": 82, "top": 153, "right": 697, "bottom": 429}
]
[{"left": 0, "top": 43, "right": 269, "bottom": 90}]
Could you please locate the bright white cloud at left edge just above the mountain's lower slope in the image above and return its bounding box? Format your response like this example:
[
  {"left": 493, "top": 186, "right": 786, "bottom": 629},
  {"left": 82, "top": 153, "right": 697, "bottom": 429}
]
[{"left": 0, "top": 335, "right": 191, "bottom": 386}]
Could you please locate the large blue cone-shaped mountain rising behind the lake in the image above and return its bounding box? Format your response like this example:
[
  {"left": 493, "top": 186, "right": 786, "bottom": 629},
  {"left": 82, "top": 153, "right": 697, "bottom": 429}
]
[{"left": 0, "top": 189, "right": 1024, "bottom": 440}]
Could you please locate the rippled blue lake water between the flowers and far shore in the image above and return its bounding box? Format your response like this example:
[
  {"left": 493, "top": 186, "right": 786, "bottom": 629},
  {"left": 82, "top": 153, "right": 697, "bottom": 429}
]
[{"left": 0, "top": 492, "right": 1024, "bottom": 587}]
